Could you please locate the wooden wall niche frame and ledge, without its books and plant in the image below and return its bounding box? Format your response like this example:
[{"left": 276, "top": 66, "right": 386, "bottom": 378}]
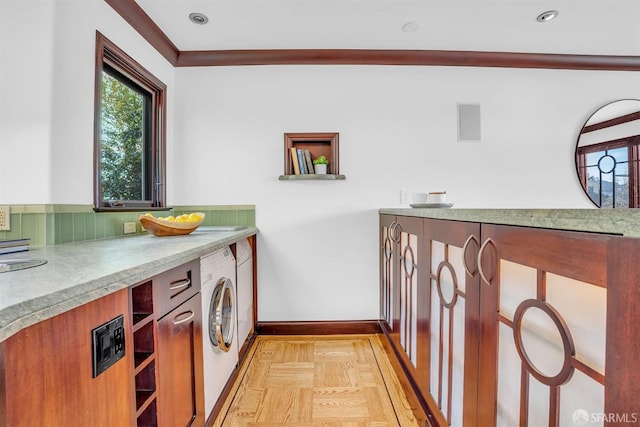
[{"left": 279, "top": 132, "right": 345, "bottom": 177}]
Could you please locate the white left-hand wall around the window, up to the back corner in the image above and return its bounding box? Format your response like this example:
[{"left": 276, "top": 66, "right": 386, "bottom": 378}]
[{"left": 0, "top": 0, "right": 174, "bottom": 204}]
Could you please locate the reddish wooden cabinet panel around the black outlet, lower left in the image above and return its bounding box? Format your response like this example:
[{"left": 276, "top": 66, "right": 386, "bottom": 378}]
[{"left": 0, "top": 289, "right": 136, "bottom": 427}]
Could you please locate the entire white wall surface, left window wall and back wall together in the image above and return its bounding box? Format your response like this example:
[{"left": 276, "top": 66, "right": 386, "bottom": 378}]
[{"left": 0, "top": 0, "right": 640, "bottom": 320}]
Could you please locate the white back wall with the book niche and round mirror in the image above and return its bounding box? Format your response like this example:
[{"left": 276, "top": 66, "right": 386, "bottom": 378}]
[{"left": 174, "top": 66, "right": 640, "bottom": 321}]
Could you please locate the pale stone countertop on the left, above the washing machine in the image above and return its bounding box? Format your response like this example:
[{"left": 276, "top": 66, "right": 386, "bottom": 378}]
[{"left": 0, "top": 227, "right": 258, "bottom": 342}]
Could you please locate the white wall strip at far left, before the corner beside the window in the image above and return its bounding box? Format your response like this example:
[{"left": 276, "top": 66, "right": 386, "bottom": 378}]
[{"left": 0, "top": 0, "right": 54, "bottom": 204}]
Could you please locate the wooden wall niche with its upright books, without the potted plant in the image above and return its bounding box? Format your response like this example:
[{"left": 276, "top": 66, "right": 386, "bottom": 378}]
[{"left": 278, "top": 132, "right": 346, "bottom": 181}]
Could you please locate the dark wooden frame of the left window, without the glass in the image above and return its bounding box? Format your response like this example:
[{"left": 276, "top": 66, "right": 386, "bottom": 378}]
[{"left": 93, "top": 31, "right": 167, "bottom": 211}]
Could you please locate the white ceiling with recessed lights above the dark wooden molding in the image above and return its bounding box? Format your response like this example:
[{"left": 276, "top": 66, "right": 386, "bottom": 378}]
[{"left": 135, "top": 0, "right": 640, "bottom": 56}]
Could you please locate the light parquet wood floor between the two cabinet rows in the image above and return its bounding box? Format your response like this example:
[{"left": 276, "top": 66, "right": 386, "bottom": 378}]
[{"left": 214, "top": 335, "right": 418, "bottom": 427}]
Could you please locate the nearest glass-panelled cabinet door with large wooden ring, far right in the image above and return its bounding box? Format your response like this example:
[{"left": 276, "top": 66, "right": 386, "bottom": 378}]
[{"left": 478, "top": 224, "right": 610, "bottom": 427}]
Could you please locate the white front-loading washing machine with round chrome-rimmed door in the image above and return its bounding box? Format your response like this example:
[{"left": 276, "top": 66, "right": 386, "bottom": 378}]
[{"left": 200, "top": 247, "right": 238, "bottom": 418}]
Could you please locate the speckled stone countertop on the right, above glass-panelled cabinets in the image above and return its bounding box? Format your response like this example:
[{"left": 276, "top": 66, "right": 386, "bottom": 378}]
[{"left": 379, "top": 207, "right": 640, "bottom": 237}]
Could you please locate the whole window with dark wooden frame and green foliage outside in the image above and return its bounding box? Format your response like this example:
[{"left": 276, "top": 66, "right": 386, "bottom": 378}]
[{"left": 94, "top": 33, "right": 166, "bottom": 210}]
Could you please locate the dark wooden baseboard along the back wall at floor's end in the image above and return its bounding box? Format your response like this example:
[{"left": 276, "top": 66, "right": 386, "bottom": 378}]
[{"left": 256, "top": 320, "right": 381, "bottom": 335}]
